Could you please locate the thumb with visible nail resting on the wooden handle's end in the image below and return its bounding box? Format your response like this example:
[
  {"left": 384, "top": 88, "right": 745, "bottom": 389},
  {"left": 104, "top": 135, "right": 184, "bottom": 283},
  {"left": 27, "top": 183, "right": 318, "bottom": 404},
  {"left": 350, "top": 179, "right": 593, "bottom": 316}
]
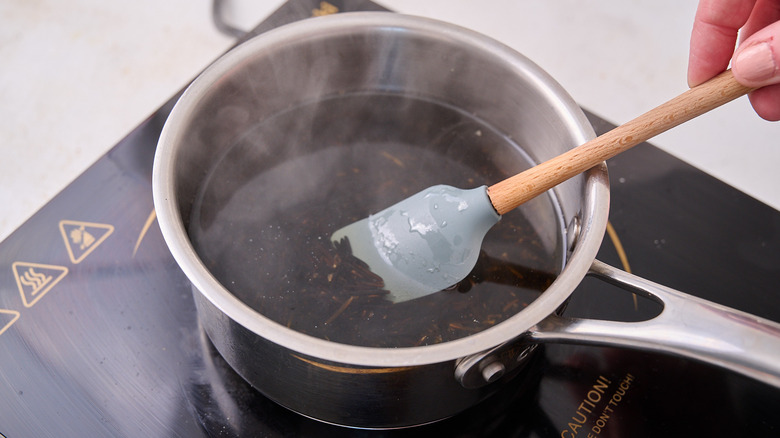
[{"left": 731, "top": 21, "right": 780, "bottom": 87}]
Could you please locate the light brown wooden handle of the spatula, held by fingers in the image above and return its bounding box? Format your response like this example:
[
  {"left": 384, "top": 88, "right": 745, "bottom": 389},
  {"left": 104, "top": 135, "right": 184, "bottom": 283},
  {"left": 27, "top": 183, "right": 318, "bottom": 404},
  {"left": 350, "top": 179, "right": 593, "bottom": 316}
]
[{"left": 488, "top": 70, "right": 752, "bottom": 214}]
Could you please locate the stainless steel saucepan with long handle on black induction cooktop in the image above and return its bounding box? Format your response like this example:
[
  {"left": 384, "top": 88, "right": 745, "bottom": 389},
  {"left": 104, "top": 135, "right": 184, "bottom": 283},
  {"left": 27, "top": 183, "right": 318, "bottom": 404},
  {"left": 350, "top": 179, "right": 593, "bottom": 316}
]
[{"left": 153, "top": 13, "right": 780, "bottom": 428}]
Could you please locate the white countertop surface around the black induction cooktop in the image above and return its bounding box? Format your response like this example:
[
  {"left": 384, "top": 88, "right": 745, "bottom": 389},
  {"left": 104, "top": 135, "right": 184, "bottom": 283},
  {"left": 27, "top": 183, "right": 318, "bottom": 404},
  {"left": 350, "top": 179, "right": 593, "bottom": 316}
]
[{"left": 0, "top": 0, "right": 780, "bottom": 240}]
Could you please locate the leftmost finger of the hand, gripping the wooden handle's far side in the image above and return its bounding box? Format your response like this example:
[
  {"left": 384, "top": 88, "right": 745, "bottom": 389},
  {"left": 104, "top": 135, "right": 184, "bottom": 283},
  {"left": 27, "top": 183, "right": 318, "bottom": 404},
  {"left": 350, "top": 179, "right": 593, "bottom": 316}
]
[{"left": 688, "top": 0, "right": 756, "bottom": 87}]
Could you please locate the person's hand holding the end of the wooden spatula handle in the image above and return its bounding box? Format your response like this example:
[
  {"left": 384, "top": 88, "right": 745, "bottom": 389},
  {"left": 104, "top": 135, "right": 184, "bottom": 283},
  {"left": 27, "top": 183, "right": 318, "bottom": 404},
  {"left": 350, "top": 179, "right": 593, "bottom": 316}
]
[{"left": 688, "top": 0, "right": 780, "bottom": 121}]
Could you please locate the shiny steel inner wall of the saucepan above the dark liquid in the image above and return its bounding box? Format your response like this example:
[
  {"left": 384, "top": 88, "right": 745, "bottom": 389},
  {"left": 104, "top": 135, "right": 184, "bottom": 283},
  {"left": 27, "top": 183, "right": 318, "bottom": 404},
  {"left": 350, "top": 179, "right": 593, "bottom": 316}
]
[{"left": 168, "top": 20, "right": 583, "bottom": 255}]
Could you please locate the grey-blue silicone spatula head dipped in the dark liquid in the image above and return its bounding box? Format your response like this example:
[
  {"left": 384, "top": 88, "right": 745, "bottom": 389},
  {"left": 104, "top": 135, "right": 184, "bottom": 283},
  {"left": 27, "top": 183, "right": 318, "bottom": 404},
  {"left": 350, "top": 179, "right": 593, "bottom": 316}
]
[{"left": 331, "top": 185, "right": 500, "bottom": 303}]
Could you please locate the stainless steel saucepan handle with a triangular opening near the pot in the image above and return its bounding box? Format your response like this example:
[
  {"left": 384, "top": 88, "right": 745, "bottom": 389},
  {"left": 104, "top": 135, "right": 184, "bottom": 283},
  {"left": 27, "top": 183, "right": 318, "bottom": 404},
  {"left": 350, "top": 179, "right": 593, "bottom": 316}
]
[{"left": 528, "top": 260, "right": 780, "bottom": 388}]
